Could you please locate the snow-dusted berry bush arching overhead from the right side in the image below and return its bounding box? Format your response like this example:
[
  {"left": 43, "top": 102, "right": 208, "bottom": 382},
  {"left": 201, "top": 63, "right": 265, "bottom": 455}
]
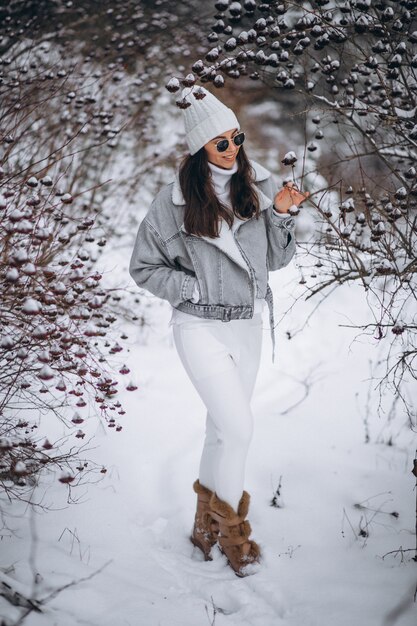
[{"left": 173, "top": 0, "right": 417, "bottom": 428}]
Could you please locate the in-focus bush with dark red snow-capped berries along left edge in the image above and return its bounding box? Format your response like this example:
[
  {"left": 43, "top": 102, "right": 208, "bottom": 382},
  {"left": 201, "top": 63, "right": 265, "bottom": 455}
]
[{"left": 0, "top": 163, "right": 132, "bottom": 498}]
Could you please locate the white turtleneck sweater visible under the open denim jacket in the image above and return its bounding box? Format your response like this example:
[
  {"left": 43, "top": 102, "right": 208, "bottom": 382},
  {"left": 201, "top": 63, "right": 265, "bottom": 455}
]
[{"left": 169, "top": 162, "right": 265, "bottom": 326}]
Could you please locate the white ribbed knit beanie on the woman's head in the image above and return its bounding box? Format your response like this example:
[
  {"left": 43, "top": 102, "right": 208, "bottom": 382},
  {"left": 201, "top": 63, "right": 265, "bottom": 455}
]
[{"left": 182, "top": 87, "right": 240, "bottom": 154}]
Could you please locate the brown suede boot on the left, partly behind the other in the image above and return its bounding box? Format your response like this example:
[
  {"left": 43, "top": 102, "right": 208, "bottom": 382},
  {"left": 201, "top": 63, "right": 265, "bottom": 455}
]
[{"left": 190, "top": 479, "right": 219, "bottom": 561}]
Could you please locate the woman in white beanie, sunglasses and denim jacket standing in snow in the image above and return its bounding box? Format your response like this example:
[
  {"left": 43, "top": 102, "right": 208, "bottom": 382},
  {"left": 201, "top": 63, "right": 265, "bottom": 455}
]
[{"left": 129, "top": 87, "right": 308, "bottom": 576}]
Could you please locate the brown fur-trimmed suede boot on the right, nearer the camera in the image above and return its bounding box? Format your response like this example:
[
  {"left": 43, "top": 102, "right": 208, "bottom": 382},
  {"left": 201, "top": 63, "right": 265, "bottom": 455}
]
[{"left": 210, "top": 491, "right": 261, "bottom": 577}]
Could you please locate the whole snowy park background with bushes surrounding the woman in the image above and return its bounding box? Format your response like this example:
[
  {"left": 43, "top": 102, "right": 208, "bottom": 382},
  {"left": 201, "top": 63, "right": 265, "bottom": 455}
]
[{"left": 0, "top": 0, "right": 417, "bottom": 626}]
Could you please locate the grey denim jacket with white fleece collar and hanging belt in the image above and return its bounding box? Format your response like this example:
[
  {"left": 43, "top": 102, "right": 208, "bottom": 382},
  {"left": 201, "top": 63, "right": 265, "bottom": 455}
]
[{"left": 129, "top": 161, "right": 296, "bottom": 362}]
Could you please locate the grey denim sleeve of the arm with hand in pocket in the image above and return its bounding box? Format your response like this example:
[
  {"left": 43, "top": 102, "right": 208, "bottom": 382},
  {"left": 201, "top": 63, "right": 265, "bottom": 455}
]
[{"left": 129, "top": 217, "right": 198, "bottom": 307}]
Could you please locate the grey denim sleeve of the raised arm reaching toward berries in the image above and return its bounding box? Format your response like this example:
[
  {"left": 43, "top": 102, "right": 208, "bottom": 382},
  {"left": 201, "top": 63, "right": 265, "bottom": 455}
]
[{"left": 266, "top": 177, "right": 296, "bottom": 271}]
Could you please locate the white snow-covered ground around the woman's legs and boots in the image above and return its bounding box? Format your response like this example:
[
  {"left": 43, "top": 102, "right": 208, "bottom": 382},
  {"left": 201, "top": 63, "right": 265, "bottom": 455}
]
[{"left": 0, "top": 245, "right": 417, "bottom": 626}]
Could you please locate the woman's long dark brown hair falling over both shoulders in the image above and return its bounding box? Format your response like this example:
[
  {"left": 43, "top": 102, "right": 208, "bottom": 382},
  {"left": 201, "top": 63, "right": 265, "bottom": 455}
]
[{"left": 179, "top": 146, "right": 260, "bottom": 238}]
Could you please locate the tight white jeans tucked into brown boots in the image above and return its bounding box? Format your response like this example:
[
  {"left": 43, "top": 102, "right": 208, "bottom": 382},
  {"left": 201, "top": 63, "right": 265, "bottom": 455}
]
[{"left": 173, "top": 313, "right": 262, "bottom": 510}]
